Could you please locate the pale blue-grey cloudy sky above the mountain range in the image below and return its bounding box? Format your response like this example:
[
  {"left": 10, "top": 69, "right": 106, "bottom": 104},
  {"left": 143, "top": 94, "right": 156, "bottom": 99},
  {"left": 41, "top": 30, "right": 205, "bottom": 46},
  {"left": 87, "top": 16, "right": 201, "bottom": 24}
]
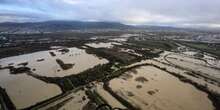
[{"left": 0, "top": 0, "right": 220, "bottom": 28}]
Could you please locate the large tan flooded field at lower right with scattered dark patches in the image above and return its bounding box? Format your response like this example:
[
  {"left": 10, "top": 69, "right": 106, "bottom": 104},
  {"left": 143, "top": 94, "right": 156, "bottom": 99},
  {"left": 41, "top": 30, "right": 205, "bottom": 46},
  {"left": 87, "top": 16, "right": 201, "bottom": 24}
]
[{"left": 110, "top": 66, "right": 214, "bottom": 110}]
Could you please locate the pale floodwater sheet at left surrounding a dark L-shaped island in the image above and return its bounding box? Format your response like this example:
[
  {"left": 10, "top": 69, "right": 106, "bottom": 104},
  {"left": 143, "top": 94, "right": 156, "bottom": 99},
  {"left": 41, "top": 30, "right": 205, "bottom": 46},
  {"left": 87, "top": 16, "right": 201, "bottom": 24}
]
[{"left": 0, "top": 48, "right": 108, "bottom": 77}]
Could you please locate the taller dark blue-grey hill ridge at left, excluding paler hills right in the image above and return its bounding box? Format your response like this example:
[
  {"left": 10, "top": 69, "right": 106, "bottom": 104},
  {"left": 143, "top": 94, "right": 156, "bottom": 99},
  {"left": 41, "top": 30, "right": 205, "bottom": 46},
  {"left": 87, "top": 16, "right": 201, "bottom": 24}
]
[{"left": 0, "top": 21, "right": 131, "bottom": 32}]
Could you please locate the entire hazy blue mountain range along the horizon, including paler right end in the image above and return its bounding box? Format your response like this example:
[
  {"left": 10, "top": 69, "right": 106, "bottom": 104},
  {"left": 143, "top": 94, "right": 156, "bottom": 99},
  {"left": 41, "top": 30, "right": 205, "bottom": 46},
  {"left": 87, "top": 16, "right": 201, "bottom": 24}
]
[{"left": 0, "top": 21, "right": 217, "bottom": 33}]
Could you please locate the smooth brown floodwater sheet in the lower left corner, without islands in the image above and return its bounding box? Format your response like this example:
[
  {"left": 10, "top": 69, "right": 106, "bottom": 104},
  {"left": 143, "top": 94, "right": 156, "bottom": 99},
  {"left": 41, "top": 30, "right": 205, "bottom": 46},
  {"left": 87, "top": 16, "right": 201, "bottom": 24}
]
[{"left": 0, "top": 69, "right": 62, "bottom": 109}]
